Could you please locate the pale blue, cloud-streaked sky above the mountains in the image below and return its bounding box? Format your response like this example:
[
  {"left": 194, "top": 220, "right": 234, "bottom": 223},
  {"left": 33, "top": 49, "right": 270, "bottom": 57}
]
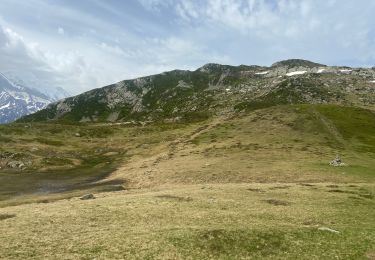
[{"left": 0, "top": 0, "right": 375, "bottom": 94}]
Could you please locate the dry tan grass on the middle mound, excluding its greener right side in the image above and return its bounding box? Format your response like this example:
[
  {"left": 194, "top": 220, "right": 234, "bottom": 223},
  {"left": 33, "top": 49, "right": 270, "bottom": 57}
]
[{"left": 106, "top": 105, "right": 375, "bottom": 188}]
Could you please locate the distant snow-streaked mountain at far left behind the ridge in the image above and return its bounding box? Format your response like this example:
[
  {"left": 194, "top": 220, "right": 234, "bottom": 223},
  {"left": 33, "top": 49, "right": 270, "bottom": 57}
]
[{"left": 0, "top": 73, "right": 53, "bottom": 124}]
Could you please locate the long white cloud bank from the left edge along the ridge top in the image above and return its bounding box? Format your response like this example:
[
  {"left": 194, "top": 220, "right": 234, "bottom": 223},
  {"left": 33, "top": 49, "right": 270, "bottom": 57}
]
[{"left": 0, "top": 22, "right": 225, "bottom": 94}]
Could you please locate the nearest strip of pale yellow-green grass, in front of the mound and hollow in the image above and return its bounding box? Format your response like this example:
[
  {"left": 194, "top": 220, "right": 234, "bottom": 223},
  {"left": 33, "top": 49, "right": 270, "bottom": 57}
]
[{"left": 0, "top": 184, "right": 375, "bottom": 259}]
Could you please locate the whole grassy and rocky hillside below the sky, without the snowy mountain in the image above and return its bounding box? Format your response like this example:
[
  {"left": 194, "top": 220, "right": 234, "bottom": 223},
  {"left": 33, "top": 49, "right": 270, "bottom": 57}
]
[{"left": 0, "top": 60, "right": 375, "bottom": 259}]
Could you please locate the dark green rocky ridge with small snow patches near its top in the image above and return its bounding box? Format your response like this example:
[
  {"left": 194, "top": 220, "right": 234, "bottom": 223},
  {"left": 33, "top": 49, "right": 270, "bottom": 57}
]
[{"left": 21, "top": 59, "right": 375, "bottom": 122}]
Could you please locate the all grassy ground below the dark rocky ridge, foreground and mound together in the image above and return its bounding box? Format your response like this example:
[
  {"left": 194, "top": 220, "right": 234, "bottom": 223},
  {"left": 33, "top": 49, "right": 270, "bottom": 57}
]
[{"left": 0, "top": 105, "right": 375, "bottom": 259}]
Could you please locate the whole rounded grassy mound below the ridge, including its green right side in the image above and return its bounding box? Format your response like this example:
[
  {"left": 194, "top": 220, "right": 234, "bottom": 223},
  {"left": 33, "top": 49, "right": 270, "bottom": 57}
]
[{"left": 104, "top": 105, "right": 375, "bottom": 187}]
